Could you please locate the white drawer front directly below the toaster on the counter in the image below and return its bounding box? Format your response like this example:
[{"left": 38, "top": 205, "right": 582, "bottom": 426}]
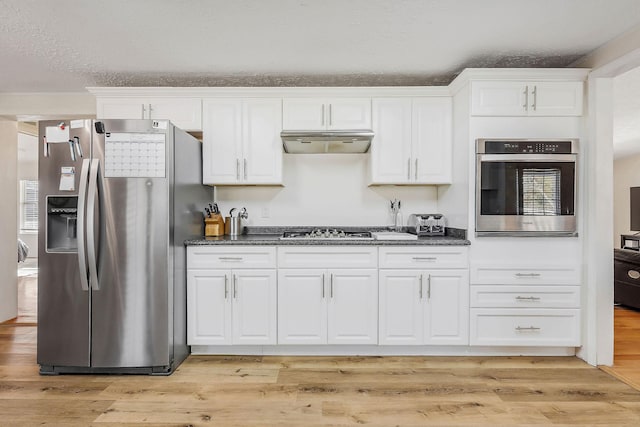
[{"left": 379, "top": 246, "right": 468, "bottom": 269}]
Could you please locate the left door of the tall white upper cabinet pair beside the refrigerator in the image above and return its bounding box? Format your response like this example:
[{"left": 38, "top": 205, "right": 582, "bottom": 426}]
[{"left": 202, "top": 98, "right": 242, "bottom": 184}]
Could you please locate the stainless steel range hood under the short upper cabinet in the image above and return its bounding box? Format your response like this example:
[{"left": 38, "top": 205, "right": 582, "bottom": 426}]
[{"left": 280, "top": 129, "right": 373, "bottom": 154}]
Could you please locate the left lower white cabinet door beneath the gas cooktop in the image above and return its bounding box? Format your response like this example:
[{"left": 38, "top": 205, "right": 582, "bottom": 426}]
[{"left": 278, "top": 269, "right": 327, "bottom": 344}]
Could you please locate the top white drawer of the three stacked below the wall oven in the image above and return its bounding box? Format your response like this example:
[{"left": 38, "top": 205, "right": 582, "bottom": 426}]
[{"left": 471, "top": 265, "right": 580, "bottom": 285}]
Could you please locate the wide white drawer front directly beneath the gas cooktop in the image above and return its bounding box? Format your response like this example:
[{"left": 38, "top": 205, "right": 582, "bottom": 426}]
[{"left": 278, "top": 246, "right": 378, "bottom": 268}]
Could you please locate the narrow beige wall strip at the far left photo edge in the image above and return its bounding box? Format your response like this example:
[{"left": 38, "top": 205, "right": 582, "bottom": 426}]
[{"left": 0, "top": 120, "right": 18, "bottom": 321}]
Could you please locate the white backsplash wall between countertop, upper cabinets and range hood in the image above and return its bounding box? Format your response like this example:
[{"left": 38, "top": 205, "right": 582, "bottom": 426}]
[{"left": 216, "top": 154, "right": 440, "bottom": 226}]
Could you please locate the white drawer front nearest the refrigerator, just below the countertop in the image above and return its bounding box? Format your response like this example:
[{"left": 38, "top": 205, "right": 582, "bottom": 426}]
[{"left": 187, "top": 246, "right": 276, "bottom": 269}]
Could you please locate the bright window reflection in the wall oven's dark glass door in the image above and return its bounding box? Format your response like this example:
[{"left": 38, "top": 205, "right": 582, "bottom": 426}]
[{"left": 522, "top": 169, "right": 560, "bottom": 215}]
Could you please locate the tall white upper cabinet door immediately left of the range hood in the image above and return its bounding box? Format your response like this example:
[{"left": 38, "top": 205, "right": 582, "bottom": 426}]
[{"left": 242, "top": 98, "right": 282, "bottom": 184}]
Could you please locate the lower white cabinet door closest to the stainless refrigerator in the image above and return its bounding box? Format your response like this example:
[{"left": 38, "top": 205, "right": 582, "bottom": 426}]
[{"left": 187, "top": 270, "right": 231, "bottom": 345}]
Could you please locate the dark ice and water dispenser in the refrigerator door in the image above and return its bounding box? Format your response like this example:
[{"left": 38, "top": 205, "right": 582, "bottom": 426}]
[{"left": 46, "top": 196, "right": 78, "bottom": 252}]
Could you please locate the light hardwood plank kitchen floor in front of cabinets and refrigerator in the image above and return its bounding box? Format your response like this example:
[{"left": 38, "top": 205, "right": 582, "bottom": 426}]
[{"left": 0, "top": 274, "right": 640, "bottom": 427}]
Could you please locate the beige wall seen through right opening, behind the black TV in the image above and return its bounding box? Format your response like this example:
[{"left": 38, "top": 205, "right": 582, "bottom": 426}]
[{"left": 613, "top": 154, "right": 640, "bottom": 248}]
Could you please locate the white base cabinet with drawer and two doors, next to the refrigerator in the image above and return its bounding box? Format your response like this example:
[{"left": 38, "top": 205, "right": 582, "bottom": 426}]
[{"left": 187, "top": 246, "right": 277, "bottom": 345}]
